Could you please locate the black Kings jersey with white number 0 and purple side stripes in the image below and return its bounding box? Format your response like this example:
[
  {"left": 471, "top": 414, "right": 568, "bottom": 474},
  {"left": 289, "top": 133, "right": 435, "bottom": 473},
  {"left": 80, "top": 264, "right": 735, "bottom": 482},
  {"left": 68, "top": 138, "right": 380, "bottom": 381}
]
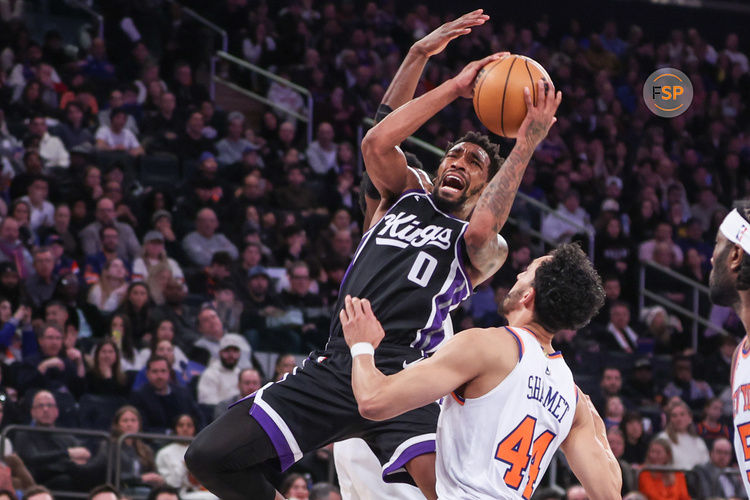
[{"left": 331, "top": 190, "right": 472, "bottom": 352}]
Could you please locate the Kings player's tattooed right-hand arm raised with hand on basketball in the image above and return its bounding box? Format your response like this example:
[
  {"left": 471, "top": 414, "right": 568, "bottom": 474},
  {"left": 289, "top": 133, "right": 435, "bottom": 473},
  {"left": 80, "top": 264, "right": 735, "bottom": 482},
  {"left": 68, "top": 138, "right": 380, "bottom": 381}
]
[{"left": 465, "top": 80, "right": 562, "bottom": 283}]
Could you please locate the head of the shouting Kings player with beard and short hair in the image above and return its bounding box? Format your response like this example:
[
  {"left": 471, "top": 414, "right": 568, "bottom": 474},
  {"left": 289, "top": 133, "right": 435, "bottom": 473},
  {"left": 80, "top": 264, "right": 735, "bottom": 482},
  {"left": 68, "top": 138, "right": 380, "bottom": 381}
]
[{"left": 432, "top": 132, "right": 505, "bottom": 213}]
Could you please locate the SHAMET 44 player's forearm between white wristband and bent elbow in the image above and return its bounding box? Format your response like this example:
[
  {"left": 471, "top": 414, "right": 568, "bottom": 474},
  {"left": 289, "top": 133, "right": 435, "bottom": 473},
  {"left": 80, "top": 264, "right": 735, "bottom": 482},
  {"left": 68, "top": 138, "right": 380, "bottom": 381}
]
[{"left": 352, "top": 355, "right": 406, "bottom": 420}]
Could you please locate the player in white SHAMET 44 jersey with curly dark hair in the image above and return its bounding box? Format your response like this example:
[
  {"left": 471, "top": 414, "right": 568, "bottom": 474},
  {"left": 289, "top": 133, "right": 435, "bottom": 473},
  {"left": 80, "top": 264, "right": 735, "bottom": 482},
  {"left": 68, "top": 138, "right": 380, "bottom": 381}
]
[{"left": 340, "top": 244, "right": 622, "bottom": 500}]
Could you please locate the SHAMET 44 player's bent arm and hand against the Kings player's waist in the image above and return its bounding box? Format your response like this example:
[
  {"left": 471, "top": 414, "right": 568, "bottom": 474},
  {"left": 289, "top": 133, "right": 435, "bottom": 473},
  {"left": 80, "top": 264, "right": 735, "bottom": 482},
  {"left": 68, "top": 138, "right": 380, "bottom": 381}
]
[{"left": 340, "top": 297, "right": 518, "bottom": 420}]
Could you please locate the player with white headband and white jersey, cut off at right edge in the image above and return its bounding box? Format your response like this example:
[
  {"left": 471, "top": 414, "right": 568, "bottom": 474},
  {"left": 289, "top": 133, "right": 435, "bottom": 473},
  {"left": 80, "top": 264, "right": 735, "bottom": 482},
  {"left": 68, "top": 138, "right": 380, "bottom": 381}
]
[{"left": 709, "top": 201, "right": 750, "bottom": 494}]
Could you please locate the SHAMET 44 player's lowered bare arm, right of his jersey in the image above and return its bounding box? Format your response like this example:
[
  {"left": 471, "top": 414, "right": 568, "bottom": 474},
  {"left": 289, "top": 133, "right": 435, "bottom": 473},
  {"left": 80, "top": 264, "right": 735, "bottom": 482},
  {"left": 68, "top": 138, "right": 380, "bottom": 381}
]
[{"left": 560, "top": 391, "right": 622, "bottom": 500}]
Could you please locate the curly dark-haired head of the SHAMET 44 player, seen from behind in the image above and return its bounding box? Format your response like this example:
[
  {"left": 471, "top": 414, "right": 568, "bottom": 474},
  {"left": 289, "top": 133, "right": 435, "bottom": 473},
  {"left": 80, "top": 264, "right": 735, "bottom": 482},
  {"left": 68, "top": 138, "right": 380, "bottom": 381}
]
[{"left": 501, "top": 244, "right": 604, "bottom": 334}]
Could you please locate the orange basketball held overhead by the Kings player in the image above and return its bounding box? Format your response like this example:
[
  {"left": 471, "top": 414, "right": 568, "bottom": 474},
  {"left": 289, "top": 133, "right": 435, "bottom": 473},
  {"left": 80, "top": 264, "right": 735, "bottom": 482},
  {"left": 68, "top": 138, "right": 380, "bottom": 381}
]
[{"left": 474, "top": 54, "right": 552, "bottom": 138}]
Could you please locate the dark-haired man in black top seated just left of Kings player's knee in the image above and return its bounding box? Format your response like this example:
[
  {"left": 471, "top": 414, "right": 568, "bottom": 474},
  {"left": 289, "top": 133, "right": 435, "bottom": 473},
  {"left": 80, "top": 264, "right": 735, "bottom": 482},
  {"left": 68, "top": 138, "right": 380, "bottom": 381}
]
[{"left": 131, "top": 356, "right": 202, "bottom": 433}]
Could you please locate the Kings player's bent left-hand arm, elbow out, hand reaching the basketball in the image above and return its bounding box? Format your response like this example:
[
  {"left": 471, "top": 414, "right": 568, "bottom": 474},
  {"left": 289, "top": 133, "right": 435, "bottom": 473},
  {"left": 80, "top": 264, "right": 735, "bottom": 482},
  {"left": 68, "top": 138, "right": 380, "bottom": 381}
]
[{"left": 362, "top": 53, "right": 501, "bottom": 198}]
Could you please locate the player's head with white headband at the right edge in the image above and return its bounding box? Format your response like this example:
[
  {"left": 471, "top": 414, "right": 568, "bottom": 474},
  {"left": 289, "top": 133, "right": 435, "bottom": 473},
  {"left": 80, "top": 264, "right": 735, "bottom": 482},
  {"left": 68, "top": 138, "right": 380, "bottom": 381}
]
[{"left": 708, "top": 200, "right": 750, "bottom": 312}]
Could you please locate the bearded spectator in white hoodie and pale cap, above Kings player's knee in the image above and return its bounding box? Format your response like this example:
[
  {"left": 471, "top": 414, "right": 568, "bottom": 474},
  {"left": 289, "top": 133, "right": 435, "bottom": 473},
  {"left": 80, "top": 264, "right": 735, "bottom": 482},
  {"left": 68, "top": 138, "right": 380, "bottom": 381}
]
[{"left": 198, "top": 333, "right": 249, "bottom": 406}]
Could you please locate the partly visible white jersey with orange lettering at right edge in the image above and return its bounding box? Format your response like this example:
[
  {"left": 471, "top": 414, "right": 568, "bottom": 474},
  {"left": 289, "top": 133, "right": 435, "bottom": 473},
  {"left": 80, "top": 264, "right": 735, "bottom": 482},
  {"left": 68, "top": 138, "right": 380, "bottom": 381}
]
[{"left": 731, "top": 339, "right": 750, "bottom": 493}]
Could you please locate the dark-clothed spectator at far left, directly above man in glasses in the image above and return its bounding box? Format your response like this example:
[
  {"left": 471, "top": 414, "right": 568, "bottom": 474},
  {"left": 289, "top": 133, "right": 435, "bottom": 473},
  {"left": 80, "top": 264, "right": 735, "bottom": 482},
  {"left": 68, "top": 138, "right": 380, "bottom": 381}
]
[{"left": 17, "top": 324, "right": 86, "bottom": 398}]
